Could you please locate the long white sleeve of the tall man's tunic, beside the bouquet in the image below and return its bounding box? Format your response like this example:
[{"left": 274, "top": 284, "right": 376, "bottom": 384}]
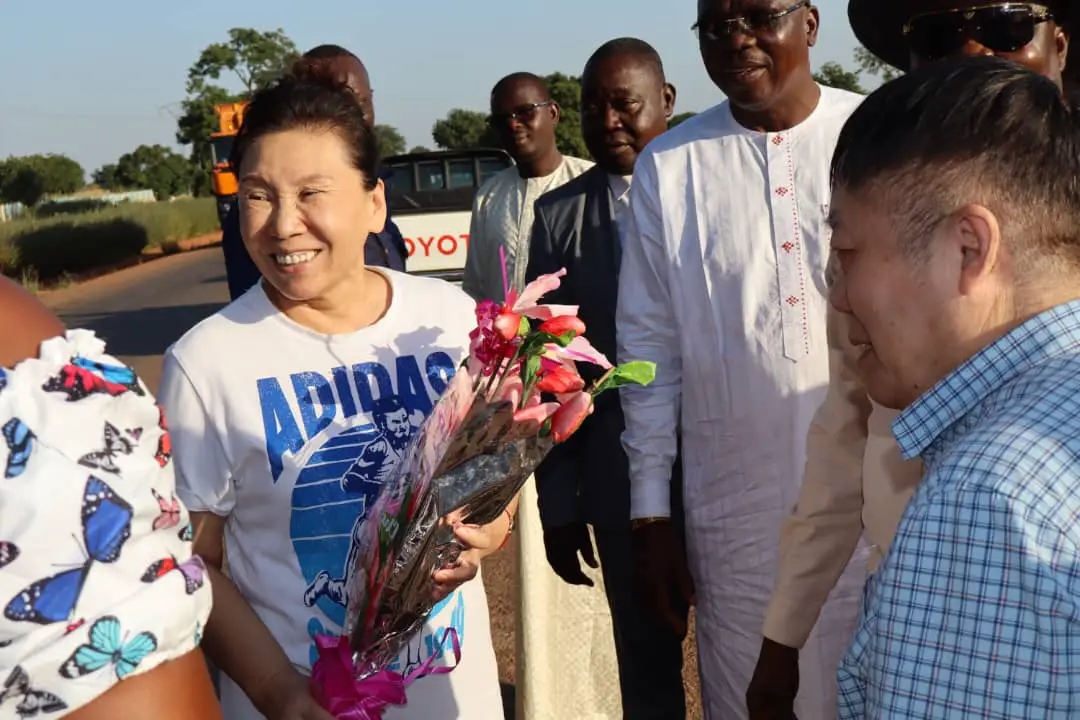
[{"left": 616, "top": 153, "right": 683, "bottom": 519}]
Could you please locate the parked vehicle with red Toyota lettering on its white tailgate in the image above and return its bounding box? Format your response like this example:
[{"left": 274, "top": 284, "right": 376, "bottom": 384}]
[{"left": 382, "top": 148, "right": 514, "bottom": 282}]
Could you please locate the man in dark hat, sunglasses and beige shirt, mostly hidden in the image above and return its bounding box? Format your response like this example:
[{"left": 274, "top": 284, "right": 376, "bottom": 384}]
[{"left": 747, "top": 0, "right": 1080, "bottom": 720}]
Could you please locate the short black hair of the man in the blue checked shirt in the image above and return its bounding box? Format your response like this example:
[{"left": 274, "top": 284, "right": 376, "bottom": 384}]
[{"left": 832, "top": 56, "right": 1080, "bottom": 268}]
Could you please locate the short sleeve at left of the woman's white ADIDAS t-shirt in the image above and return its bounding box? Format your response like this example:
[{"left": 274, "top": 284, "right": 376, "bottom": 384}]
[{"left": 158, "top": 350, "right": 237, "bottom": 517}]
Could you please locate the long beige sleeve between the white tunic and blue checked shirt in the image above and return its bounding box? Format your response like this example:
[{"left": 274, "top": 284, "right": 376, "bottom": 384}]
[{"left": 765, "top": 308, "right": 873, "bottom": 648}]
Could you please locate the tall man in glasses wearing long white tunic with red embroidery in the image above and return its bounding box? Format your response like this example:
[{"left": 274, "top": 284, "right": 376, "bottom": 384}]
[{"left": 616, "top": 0, "right": 865, "bottom": 720}]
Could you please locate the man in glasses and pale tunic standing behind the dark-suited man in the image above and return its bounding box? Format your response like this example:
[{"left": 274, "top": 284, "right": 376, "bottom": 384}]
[{"left": 461, "top": 72, "right": 593, "bottom": 302}]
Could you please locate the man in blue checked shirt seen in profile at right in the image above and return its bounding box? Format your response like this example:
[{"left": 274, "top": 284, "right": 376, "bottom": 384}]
[{"left": 829, "top": 56, "right": 1080, "bottom": 720}]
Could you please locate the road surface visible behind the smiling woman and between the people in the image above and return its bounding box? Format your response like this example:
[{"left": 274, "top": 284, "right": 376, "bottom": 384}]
[{"left": 41, "top": 246, "right": 701, "bottom": 718}]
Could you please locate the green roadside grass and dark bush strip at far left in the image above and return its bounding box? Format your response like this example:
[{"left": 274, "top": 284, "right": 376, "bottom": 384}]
[{"left": 0, "top": 198, "right": 219, "bottom": 283}]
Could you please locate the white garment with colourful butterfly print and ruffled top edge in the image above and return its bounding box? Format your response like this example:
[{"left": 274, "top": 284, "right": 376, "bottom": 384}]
[{"left": 0, "top": 330, "right": 211, "bottom": 720}]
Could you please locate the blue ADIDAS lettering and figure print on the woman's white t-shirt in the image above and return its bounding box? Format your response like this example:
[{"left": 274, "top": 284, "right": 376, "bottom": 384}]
[{"left": 258, "top": 352, "right": 464, "bottom": 674}]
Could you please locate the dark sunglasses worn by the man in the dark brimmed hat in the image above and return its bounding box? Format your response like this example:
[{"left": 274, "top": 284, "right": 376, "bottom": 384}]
[{"left": 904, "top": 2, "right": 1054, "bottom": 62}]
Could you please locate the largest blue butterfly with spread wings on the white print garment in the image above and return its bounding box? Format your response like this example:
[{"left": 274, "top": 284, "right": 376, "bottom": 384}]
[{"left": 3, "top": 476, "right": 134, "bottom": 625}]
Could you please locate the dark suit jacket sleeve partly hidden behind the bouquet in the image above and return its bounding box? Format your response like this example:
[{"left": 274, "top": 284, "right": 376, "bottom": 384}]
[{"left": 525, "top": 204, "right": 591, "bottom": 528}]
